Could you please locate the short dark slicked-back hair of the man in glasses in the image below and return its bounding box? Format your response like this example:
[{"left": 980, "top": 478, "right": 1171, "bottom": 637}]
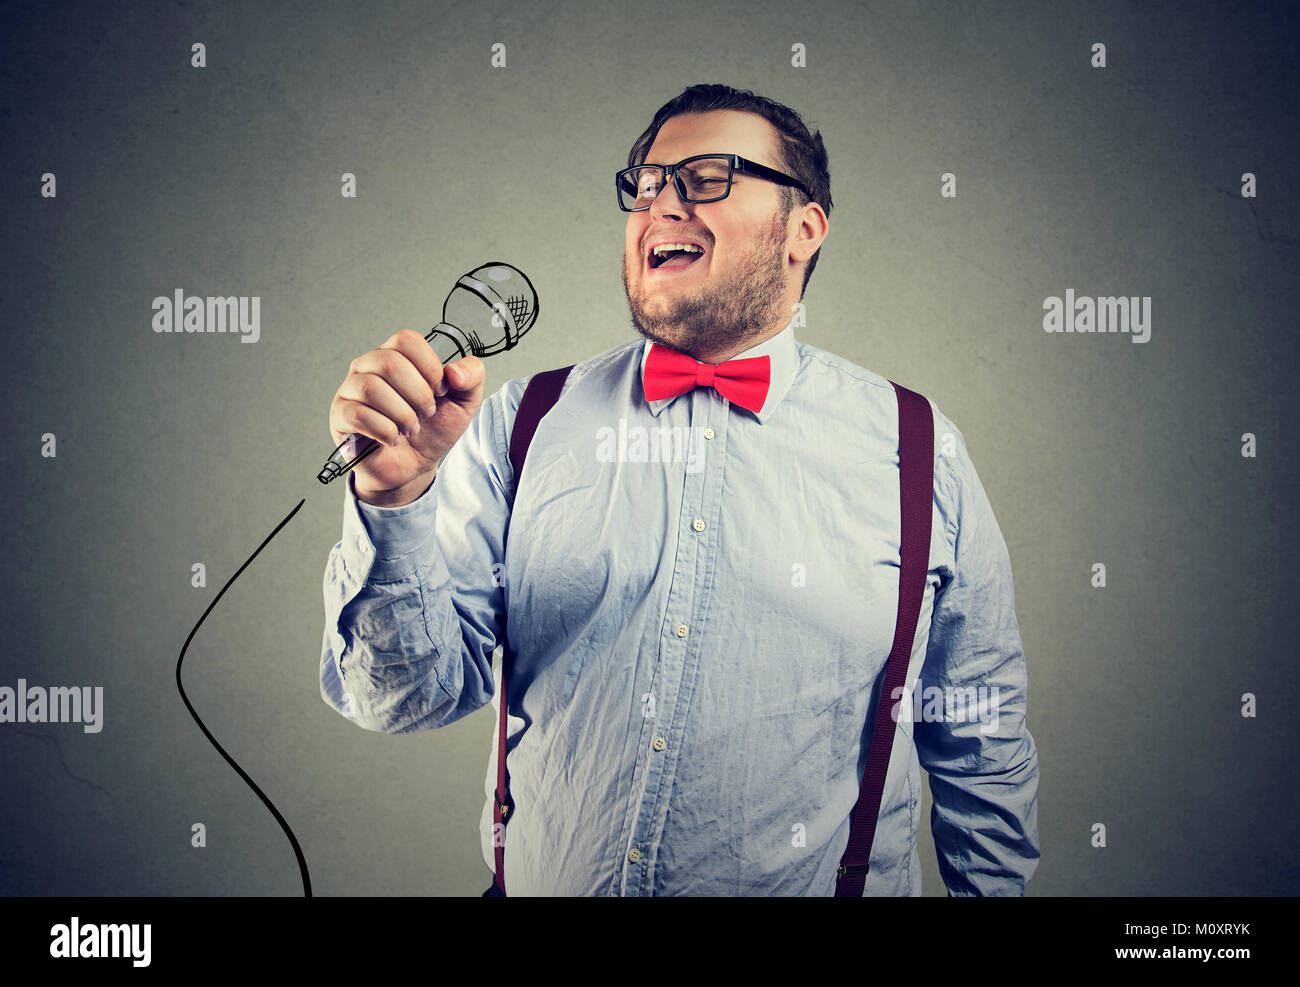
[{"left": 628, "top": 85, "right": 831, "bottom": 298}]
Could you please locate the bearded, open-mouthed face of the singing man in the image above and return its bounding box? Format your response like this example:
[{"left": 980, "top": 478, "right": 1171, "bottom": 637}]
[{"left": 623, "top": 109, "right": 802, "bottom": 362}]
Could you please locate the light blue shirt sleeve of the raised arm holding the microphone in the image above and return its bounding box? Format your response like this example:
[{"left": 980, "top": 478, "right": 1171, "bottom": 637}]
[{"left": 320, "top": 389, "right": 514, "bottom": 733}]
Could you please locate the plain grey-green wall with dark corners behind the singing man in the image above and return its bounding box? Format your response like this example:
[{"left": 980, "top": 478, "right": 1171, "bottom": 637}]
[{"left": 0, "top": 0, "right": 1300, "bottom": 895}]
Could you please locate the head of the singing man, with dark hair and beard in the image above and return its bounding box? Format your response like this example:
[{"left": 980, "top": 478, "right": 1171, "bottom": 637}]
[{"left": 623, "top": 86, "right": 831, "bottom": 360}]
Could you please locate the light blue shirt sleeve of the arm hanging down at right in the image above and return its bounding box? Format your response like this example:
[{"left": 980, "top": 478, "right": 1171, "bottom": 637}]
[{"left": 914, "top": 421, "right": 1039, "bottom": 896}]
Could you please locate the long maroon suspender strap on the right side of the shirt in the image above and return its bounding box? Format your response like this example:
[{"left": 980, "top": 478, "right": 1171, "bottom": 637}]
[{"left": 835, "top": 381, "right": 935, "bottom": 897}]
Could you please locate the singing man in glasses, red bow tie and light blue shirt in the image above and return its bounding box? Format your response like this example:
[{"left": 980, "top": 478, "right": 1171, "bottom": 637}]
[{"left": 321, "top": 86, "right": 1039, "bottom": 895}]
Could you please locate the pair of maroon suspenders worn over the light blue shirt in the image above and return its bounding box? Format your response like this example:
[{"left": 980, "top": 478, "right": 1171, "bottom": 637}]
[{"left": 489, "top": 367, "right": 935, "bottom": 897}]
